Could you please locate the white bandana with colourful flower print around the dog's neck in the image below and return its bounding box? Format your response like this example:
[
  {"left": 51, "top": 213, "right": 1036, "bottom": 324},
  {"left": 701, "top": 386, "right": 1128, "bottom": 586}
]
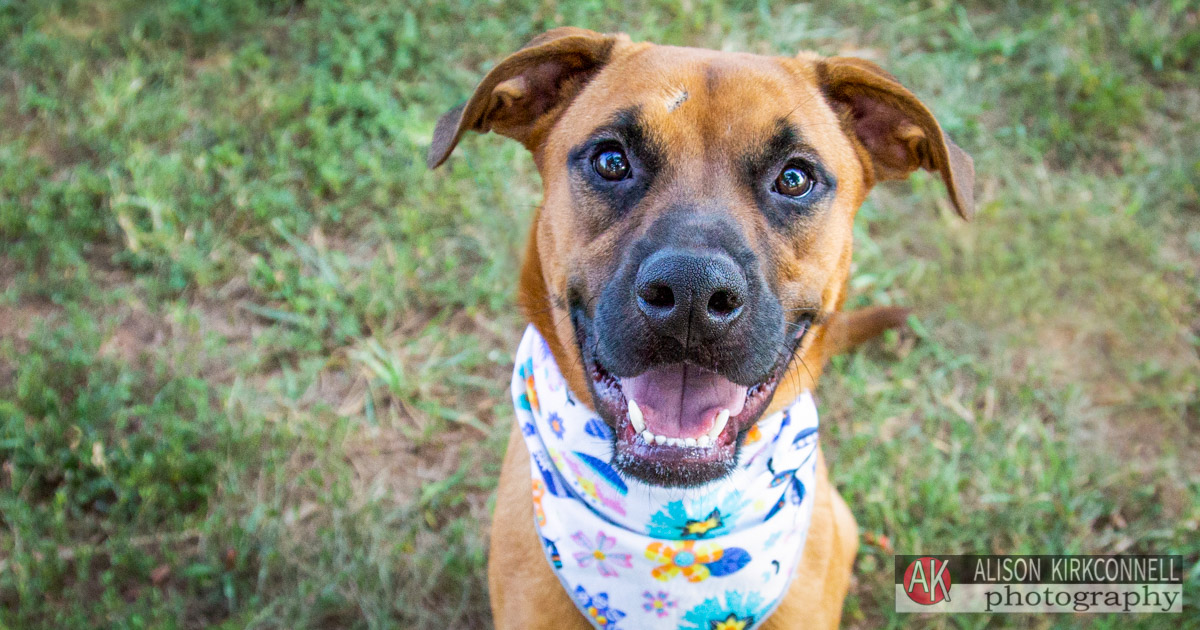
[{"left": 511, "top": 325, "right": 817, "bottom": 630}]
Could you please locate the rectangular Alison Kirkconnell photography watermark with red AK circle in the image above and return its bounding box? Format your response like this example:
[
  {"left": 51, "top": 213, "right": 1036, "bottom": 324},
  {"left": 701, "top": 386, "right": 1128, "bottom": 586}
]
[{"left": 895, "top": 556, "right": 1187, "bottom": 613}]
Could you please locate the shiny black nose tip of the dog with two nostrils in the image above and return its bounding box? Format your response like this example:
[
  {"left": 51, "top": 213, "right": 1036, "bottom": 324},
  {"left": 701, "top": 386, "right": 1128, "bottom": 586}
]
[{"left": 634, "top": 248, "right": 749, "bottom": 347}]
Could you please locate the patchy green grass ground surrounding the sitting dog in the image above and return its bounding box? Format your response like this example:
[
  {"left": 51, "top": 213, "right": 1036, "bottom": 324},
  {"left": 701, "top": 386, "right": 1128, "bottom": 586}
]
[{"left": 0, "top": 0, "right": 1200, "bottom": 628}]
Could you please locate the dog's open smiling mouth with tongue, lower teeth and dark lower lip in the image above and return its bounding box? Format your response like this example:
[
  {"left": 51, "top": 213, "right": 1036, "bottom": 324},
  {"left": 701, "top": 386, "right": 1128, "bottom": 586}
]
[{"left": 576, "top": 314, "right": 812, "bottom": 486}]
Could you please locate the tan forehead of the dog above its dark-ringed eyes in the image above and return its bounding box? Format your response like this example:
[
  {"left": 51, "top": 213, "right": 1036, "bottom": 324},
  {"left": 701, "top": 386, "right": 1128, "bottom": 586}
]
[{"left": 556, "top": 44, "right": 836, "bottom": 154}]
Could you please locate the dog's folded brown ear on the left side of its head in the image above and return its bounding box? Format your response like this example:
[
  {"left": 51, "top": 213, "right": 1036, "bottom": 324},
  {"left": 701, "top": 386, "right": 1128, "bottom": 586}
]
[{"left": 426, "top": 26, "right": 617, "bottom": 168}]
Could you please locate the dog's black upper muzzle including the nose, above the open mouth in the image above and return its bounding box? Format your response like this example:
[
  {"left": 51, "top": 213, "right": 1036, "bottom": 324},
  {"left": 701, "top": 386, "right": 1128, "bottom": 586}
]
[{"left": 594, "top": 205, "right": 784, "bottom": 385}]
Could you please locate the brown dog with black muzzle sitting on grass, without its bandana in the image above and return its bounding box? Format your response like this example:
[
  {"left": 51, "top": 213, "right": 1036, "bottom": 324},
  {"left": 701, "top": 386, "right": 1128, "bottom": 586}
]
[{"left": 428, "top": 28, "right": 974, "bottom": 629}]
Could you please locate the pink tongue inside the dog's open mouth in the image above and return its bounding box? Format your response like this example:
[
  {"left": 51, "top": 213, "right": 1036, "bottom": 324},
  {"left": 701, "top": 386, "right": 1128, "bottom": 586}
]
[{"left": 620, "top": 364, "right": 746, "bottom": 438}]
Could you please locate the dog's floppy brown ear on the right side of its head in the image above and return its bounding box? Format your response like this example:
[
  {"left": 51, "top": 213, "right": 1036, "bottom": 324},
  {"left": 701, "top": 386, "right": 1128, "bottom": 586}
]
[{"left": 817, "top": 56, "right": 974, "bottom": 218}]
